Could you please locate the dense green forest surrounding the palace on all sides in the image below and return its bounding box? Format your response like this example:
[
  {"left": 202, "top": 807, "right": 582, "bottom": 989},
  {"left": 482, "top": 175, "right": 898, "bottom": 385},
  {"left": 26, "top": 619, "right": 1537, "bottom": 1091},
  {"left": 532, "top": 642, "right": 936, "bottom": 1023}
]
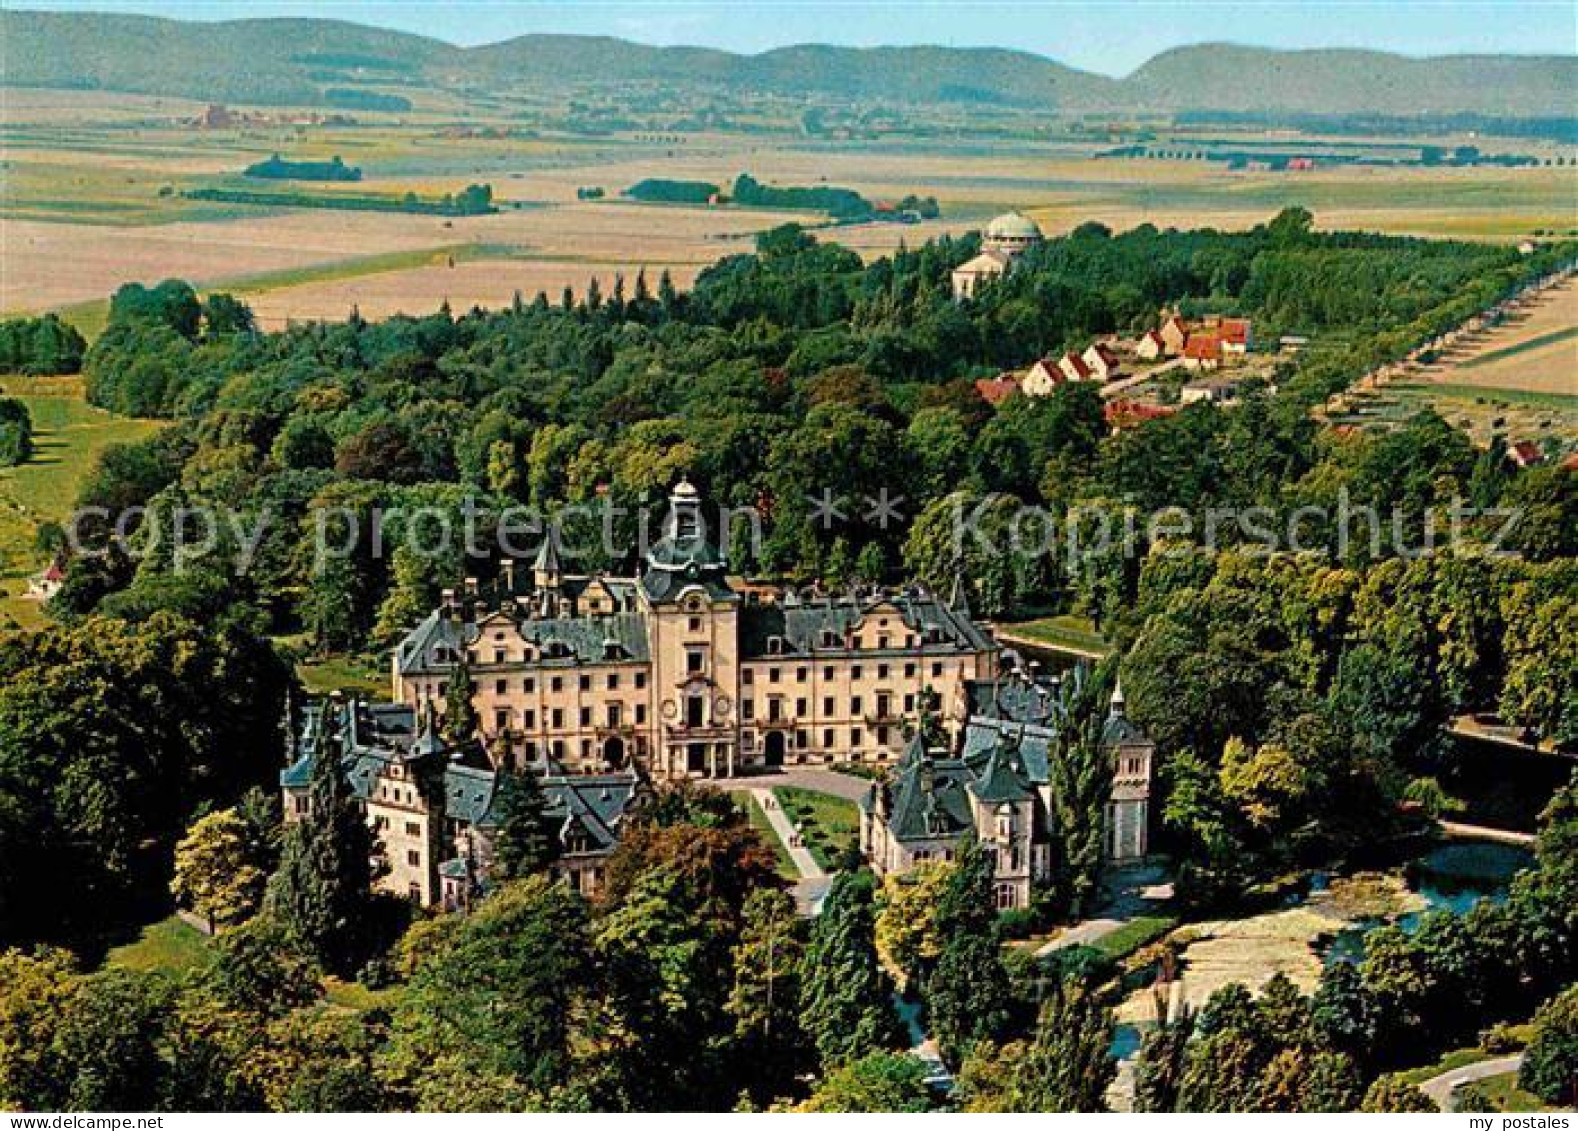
[{"left": 0, "top": 210, "right": 1578, "bottom": 1110}]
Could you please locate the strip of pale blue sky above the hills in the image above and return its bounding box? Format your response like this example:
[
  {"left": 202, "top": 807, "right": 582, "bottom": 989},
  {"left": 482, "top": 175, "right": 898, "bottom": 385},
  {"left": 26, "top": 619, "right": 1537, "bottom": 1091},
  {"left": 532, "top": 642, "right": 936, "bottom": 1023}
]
[{"left": 15, "top": 0, "right": 1578, "bottom": 76}]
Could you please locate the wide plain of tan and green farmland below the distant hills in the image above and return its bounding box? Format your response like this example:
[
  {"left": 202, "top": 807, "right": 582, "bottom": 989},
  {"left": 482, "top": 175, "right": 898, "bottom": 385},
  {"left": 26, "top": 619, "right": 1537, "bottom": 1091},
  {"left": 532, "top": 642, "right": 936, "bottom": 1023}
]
[{"left": 0, "top": 90, "right": 1573, "bottom": 334}]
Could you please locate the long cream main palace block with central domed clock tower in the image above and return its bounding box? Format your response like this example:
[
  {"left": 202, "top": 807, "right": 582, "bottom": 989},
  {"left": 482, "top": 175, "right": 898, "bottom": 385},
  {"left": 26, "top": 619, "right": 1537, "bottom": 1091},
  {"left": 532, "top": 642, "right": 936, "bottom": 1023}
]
[{"left": 393, "top": 483, "right": 999, "bottom": 779}]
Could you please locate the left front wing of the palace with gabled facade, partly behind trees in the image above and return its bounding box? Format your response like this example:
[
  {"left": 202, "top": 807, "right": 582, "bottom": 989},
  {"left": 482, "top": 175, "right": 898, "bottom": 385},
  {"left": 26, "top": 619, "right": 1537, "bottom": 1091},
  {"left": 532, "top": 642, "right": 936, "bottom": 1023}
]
[{"left": 279, "top": 696, "right": 649, "bottom": 910}]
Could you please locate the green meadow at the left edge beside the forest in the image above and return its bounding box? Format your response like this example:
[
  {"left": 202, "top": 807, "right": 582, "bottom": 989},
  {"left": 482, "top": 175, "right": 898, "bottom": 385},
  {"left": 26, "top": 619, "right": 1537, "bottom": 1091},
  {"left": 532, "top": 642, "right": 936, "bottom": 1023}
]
[{"left": 0, "top": 377, "right": 161, "bottom": 628}]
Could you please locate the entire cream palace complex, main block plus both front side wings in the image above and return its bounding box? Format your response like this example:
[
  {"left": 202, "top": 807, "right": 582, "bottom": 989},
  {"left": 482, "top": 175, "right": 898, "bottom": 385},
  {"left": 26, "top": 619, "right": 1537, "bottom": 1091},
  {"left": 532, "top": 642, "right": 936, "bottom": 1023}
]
[{"left": 279, "top": 483, "right": 1152, "bottom": 909}]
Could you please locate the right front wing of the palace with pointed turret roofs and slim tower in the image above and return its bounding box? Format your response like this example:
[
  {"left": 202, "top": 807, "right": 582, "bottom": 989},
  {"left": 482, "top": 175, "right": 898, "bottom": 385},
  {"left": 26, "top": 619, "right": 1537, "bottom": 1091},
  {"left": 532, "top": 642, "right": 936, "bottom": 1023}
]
[{"left": 860, "top": 675, "right": 1155, "bottom": 910}]
